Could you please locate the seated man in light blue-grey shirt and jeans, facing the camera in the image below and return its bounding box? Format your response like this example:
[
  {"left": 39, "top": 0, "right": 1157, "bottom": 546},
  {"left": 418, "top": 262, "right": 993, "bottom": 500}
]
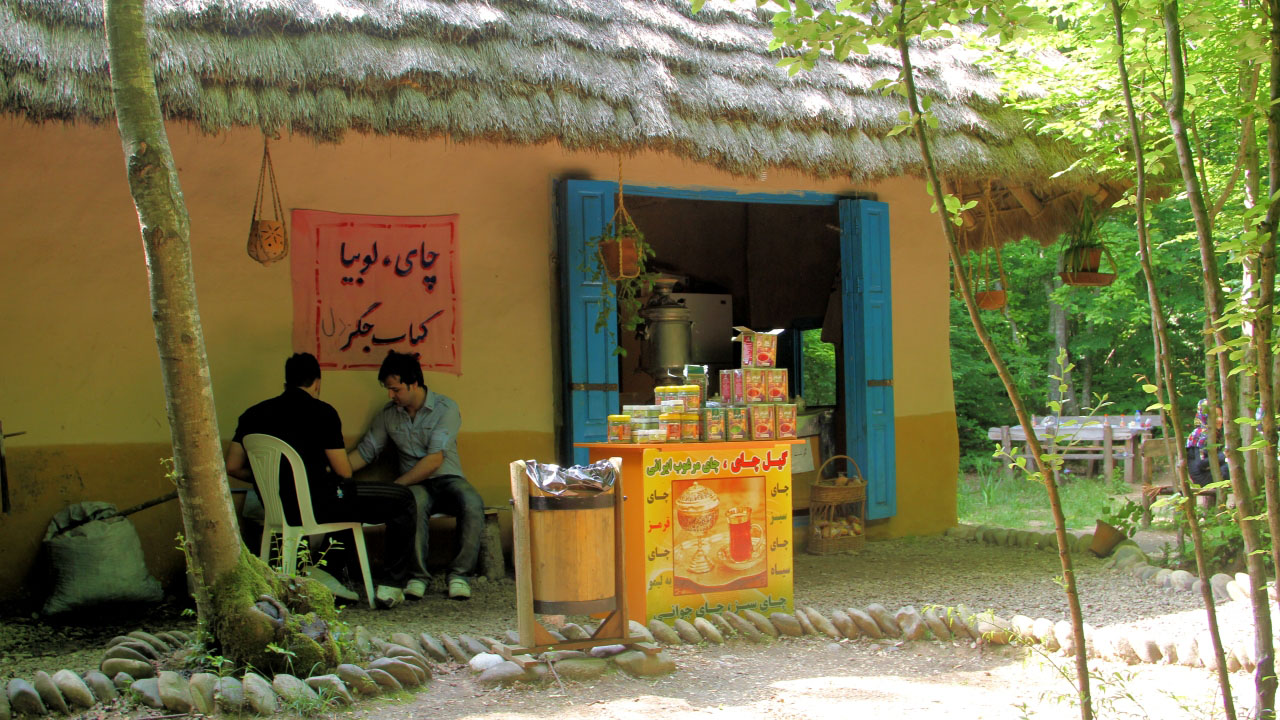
[{"left": 349, "top": 350, "right": 484, "bottom": 600}]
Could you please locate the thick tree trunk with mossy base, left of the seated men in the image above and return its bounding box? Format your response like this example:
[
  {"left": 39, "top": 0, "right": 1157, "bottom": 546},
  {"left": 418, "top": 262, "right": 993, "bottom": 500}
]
[{"left": 105, "top": 0, "right": 338, "bottom": 669}]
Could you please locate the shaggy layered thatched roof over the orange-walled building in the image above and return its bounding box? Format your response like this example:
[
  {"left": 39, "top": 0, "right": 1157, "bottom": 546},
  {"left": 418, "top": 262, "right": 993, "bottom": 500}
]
[{"left": 0, "top": 0, "right": 1111, "bottom": 245}]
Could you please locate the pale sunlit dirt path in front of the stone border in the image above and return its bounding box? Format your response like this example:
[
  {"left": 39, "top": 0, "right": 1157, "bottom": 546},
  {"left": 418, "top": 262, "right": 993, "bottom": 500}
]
[{"left": 340, "top": 638, "right": 1247, "bottom": 720}]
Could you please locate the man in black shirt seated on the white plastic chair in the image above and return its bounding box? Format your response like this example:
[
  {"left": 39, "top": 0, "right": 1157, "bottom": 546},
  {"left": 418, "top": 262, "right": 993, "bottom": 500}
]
[{"left": 227, "top": 352, "right": 426, "bottom": 605}]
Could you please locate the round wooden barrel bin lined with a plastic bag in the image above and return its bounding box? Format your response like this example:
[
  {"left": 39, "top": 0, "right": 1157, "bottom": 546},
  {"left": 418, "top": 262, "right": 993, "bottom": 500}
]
[{"left": 529, "top": 483, "right": 617, "bottom": 615}]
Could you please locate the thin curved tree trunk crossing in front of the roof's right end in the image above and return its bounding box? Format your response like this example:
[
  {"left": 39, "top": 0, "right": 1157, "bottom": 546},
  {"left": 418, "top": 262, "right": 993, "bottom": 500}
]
[{"left": 893, "top": 0, "right": 1093, "bottom": 720}]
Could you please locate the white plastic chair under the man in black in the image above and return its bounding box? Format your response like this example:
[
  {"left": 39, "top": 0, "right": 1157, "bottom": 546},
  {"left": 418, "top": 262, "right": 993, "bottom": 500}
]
[{"left": 244, "top": 433, "right": 376, "bottom": 607}]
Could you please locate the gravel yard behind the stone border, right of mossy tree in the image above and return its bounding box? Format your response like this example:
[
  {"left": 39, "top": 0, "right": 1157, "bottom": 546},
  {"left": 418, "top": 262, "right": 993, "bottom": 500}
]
[{"left": 344, "top": 537, "right": 1252, "bottom": 655}]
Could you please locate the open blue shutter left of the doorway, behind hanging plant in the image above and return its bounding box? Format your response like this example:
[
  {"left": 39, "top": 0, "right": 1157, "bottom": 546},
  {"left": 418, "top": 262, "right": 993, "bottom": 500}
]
[{"left": 559, "top": 181, "right": 618, "bottom": 464}]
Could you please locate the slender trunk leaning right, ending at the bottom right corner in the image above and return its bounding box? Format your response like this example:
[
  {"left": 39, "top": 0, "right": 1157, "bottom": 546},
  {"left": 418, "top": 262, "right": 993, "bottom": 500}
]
[{"left": 1161, "top": 0, "right": 1277, "bottom": 717}]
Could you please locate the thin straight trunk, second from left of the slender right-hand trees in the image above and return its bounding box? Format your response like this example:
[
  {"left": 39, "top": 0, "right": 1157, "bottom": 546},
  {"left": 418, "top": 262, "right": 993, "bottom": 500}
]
[{"left": 1111, "top": 0, "right": 1235, "bottom": 720}]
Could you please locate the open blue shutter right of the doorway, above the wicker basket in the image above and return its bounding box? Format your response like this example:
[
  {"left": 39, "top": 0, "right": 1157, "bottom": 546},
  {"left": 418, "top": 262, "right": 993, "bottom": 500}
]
[{"left": 840, "top": 200, "right": 897, "bottom": 519}]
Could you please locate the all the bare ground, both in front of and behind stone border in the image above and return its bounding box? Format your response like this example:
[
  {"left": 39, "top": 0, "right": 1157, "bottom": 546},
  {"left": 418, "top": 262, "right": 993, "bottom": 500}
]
[{"left": 0, "top": 530, "right": 1252, "bottom": 720}]
